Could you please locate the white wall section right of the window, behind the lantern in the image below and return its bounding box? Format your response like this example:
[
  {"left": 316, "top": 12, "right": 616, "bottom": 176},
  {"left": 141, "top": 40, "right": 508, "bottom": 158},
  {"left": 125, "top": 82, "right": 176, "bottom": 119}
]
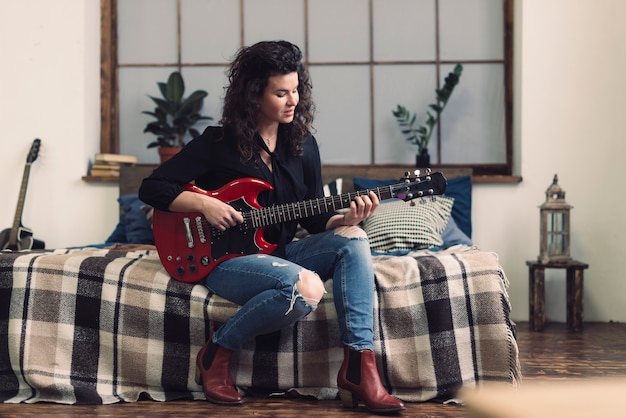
[{"left": 473, "top": 0, "right": 626, "bottom": 322}]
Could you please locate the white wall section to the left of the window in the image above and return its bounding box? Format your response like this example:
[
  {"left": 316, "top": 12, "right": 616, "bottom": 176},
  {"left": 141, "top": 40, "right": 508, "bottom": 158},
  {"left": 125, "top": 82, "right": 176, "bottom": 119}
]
[{"left": 0, "top": 0, "right": 118, "bottom": 248}]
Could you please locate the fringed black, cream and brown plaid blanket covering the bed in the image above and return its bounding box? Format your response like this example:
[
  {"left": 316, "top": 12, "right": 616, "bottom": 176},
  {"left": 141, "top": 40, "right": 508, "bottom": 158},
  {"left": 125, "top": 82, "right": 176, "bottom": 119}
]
[{"left": 0, "top": 249, "right": 520, "bottom": 404}]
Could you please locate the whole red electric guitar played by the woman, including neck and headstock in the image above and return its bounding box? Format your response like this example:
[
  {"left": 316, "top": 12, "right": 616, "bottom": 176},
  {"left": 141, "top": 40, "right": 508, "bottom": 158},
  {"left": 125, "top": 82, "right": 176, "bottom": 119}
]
[{"left": 152, "top": 173, "right": 447, "bottom": 283}]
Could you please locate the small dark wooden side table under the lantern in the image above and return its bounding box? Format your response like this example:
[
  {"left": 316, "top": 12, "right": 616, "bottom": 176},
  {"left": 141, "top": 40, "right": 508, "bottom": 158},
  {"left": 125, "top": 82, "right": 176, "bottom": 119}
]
[{"left": 526, "top": 260, "right": 589, "bottom": 332}]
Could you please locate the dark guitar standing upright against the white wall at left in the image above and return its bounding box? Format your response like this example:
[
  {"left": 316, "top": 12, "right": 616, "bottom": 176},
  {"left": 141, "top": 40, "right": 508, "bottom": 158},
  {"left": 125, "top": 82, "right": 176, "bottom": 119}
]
[{"left": 0, "top": 139, "right": 46, "bottom": 251}]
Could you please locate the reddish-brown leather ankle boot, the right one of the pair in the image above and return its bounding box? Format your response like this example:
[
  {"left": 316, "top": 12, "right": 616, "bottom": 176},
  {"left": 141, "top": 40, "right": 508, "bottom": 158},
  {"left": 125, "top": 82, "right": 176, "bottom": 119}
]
[{"left": 337, "top": 347, "right": 406, "bottom": 413}]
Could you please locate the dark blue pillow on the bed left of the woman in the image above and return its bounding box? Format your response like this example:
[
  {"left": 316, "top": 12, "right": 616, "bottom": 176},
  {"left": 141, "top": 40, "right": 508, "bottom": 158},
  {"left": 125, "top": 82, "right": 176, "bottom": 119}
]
[{"left": 106, "top": 194, "right": 154, "bottom": 244}]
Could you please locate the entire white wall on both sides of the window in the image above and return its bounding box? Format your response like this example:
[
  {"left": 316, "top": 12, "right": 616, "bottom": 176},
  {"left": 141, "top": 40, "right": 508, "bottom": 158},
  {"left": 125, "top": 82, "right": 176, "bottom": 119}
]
[{"left": 0, "top": 0, "right": 626, "bottom": 322}]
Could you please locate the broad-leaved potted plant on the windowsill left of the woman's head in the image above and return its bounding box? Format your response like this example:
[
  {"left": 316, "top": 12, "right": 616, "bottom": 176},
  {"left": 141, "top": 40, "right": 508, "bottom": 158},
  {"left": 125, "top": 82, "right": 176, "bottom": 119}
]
[{"left": 142, "top": 71, "right": 213, "bottom": 162}]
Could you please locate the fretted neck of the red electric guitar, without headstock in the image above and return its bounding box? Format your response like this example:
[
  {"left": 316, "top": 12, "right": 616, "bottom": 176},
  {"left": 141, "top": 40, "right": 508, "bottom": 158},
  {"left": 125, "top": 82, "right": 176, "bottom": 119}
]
[{"left": 243, "top": 186, "right": 393, "bottom": 229}]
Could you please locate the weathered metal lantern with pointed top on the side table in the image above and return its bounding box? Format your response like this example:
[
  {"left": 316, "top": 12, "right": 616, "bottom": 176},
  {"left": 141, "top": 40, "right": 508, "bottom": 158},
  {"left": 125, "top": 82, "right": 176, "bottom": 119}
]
[{"left": 538, "top": 174, "right": 572, "bottom": 264}]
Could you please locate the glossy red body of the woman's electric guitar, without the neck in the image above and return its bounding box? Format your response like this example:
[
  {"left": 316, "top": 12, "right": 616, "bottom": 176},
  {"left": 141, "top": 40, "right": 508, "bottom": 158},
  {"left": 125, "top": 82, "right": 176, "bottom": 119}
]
[{"left": 152, "top": 178, "right": 276, "bottom": 283}]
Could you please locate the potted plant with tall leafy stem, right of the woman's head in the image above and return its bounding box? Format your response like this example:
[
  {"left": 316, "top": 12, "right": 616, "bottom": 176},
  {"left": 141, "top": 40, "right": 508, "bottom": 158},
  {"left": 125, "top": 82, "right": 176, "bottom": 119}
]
[{"left": 391, "top": 64, "right": 463, "bottom": 168}]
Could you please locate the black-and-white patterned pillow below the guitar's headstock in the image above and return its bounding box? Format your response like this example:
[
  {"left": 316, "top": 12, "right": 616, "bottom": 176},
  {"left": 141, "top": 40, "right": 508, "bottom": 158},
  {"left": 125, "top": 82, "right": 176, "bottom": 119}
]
[{"left": 363, "top": 196, "right": 454, "bottom": 253}]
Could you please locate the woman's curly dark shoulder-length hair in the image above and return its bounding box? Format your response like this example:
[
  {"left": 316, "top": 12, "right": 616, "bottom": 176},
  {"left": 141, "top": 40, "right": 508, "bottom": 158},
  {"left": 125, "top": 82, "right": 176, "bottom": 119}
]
[{"left": 220, "top": 41, "right": 315, "bottom": 161}]
